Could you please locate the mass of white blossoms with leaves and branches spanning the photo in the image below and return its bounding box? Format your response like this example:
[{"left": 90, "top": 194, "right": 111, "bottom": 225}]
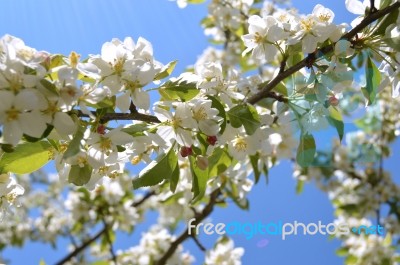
[{"left": 0, "top": 0, "right": 400, "bottom": 264}]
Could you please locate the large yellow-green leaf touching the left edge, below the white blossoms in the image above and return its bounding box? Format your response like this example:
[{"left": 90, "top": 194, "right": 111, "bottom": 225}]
[{"left": 0, "top": 141, "right": 53, "bottom": 174}]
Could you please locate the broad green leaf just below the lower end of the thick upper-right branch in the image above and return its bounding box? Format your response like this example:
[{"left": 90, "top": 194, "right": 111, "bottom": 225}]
[{"left": 228, "top": 104, "right": 261, "bottom": 135}]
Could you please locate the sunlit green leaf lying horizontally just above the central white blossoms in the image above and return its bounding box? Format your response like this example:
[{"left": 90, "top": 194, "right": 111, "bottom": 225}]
[{"left": 158, "top": 79, "right": 200, "bottom": 101}]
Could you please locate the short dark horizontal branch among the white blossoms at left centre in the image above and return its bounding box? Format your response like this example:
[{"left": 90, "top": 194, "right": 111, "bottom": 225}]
[{"left": 75, "top": 110, "right": 161, "bottom": 123}]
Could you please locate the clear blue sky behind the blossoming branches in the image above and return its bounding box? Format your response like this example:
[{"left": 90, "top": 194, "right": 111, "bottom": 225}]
[{"left": 0, "top": 0, "right": 394, "bottom": 265}]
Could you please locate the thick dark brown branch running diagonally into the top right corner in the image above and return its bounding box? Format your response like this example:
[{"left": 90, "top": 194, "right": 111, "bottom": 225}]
[{"left": 247, "top": 2, "right": 400, "bottom": 104}]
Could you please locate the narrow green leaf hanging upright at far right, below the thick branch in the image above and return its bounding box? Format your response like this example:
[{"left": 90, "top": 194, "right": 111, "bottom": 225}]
[{"left": 363, "top": 57, "right": 381, "bottom": 106}]
